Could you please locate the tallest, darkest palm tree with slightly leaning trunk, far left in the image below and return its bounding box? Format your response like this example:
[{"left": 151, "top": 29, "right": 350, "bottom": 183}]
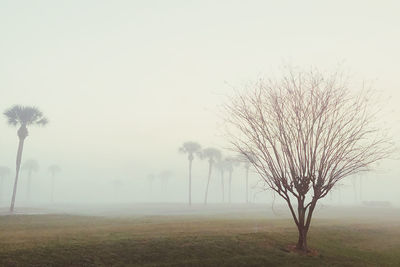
[{"left": 4, "top": 105, "right": 48, "bottom": 212}]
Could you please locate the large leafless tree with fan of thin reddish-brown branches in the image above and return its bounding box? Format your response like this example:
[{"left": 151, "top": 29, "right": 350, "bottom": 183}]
[{"left": 225, "top": 68, "right": 392, "bottom": 251}]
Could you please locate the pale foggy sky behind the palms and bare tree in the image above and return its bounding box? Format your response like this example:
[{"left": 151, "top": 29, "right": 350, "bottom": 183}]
[{"left": 0, "top": 0, "right": 400, "bottom": 206}]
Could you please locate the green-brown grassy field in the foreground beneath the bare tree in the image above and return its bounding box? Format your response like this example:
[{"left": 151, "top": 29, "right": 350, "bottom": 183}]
[{"left": 0, "top": 215, "right": 400, "bottom": 266}]
